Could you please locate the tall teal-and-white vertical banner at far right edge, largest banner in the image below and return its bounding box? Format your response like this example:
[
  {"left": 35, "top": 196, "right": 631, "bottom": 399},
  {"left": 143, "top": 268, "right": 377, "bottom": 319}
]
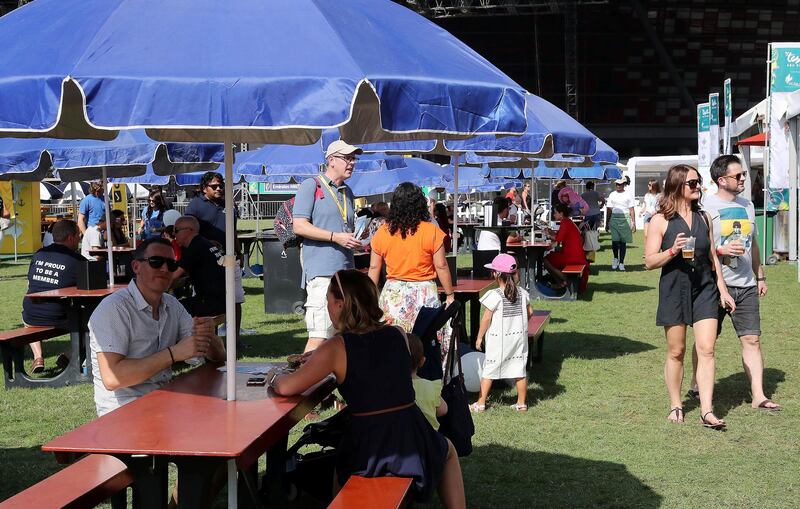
[{"left": 767, "top": 42, "right": 800, "bottom": 189}]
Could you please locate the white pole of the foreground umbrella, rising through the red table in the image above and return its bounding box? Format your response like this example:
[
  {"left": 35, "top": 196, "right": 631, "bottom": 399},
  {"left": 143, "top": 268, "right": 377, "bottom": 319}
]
[{"left": 224, "top": 135, "right": 238, "bottom": 508}]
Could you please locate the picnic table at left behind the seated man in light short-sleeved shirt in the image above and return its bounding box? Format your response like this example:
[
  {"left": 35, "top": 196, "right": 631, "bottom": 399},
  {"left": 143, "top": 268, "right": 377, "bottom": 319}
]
[{"left": 26, "top": 284, "right": 128, "bottom": 387}]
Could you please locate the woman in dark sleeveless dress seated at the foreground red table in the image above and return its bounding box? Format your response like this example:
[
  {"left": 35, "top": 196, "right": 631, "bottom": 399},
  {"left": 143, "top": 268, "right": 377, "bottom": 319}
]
[{"left": 267, "top": 268, "right": 466, "bottom": 508}]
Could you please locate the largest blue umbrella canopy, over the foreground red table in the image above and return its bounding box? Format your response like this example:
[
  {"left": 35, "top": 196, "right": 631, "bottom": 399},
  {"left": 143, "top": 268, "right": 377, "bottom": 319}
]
[{"left": 0, "top": 0, "right": 525, "bottom": 144}]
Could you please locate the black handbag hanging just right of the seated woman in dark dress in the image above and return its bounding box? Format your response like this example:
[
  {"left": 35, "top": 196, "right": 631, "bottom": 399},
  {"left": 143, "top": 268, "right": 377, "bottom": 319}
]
[{"left": 438, "top": 313, "right": 475, "bottom": 456}]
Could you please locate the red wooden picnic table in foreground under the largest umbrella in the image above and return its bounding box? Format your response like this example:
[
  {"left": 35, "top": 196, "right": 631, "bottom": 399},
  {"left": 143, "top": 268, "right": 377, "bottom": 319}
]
[{"left": 42, "top": 363, "right": 336, "bottom": 508}]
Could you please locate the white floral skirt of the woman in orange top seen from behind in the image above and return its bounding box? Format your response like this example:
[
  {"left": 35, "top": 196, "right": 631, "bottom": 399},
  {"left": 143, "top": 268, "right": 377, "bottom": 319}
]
[{"left": 378, "top": 279, "right": 451, "bottom": 360}]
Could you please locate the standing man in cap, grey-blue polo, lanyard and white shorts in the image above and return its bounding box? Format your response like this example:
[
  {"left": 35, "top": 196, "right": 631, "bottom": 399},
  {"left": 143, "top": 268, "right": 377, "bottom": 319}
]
[{"left": 292, "top": 140, "right": 363, "bottom": 352}]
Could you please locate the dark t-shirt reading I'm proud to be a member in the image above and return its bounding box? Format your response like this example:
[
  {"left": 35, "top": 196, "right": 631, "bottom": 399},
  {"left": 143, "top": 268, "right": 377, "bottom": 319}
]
[{"left": 22, "top": 244, "right": 86, "bottom": 325}]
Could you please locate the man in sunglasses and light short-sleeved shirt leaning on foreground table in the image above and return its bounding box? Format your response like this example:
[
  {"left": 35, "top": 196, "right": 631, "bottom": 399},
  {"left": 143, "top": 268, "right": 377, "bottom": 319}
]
[{"left": 89, "top": 237, "right": 225, "bottom": 415}]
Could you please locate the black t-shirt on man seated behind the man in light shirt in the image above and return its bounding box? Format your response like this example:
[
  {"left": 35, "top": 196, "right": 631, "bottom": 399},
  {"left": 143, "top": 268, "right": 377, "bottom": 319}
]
[{"left": 178, "top": 235, "right": 225, "bottom": 316}]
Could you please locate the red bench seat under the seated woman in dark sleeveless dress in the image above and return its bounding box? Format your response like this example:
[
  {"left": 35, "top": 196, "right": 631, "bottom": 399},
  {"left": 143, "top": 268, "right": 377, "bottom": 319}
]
[{"left": 328, "top": 475, "right": 412, "bottom": 509}]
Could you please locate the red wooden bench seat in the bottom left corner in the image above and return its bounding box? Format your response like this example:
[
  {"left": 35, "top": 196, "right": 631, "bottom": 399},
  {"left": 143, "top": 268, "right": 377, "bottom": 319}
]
[{"left": 0, "top": 454, "right": 133, "bottom": 509}]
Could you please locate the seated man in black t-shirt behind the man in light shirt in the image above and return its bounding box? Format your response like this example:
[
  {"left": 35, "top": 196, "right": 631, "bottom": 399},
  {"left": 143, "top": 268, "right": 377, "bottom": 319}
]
[{"left": 172, "top": 216, "right": 225, "bottom": 316}]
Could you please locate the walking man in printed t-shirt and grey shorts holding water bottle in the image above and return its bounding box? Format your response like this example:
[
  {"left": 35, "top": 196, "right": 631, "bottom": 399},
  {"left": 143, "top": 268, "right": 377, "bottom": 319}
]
[{"left": 690, "top": 155, "right": 781, "bottom": 411}]
